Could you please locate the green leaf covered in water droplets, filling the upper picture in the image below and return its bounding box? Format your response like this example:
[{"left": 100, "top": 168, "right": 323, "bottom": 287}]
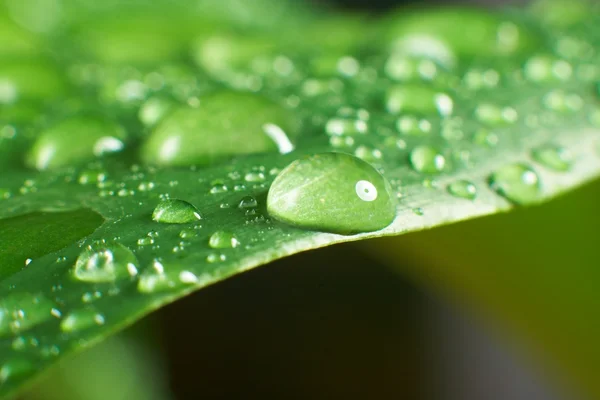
[{"left": 0, "top": 0, "right": 600, "bottom": 395}]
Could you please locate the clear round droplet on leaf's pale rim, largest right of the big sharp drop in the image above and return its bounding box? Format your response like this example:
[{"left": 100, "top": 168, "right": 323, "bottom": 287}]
[{"left": 489, "top": 164, "right": 541, "bottom": 205}]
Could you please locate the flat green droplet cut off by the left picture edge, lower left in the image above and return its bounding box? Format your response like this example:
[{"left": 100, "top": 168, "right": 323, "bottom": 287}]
[{"left": 0, "top": 293, "right": 57, "bottom": 336}]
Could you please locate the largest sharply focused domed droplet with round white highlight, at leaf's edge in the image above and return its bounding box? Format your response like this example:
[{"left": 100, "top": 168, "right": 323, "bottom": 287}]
[{"left": 267, "top": 153, "right": 396, "bottom": 234}]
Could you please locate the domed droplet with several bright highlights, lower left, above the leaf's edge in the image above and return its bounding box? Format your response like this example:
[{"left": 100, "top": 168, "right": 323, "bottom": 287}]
[{"left": 73, "top": 243, "right": 138, "bottom": 283}]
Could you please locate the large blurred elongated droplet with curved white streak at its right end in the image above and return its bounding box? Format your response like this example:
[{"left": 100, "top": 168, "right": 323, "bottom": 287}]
[{"left": 141, "top": 91, "right": 297, "bottom": 166}]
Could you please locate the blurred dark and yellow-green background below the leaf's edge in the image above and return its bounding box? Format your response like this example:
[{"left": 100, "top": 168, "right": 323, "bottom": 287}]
[{"left": 18, "top": 182, "right": 600, "bottom": 400}]
